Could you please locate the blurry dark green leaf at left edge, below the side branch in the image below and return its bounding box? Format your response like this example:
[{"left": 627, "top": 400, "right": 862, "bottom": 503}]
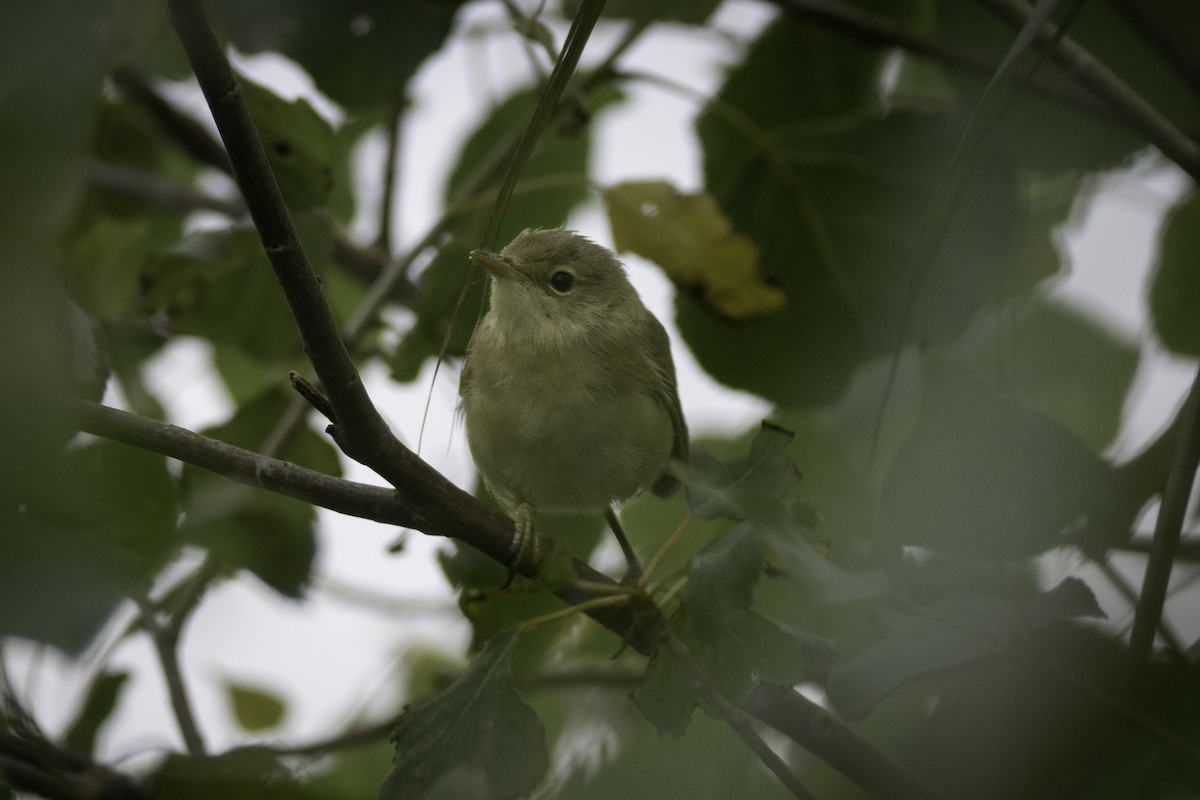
[{"left": 0, "top": 440, "right": 179, "bottom": 652}]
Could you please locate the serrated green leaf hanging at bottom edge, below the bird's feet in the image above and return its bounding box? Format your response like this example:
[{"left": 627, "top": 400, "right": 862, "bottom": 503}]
[{"left": 379, "top": 631, "right": 550, "bottom": 800}]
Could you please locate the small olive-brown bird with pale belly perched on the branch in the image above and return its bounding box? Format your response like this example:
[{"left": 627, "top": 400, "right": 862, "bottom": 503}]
[{"left": 458, "top": 229, "right": 688, "bottom": 584}]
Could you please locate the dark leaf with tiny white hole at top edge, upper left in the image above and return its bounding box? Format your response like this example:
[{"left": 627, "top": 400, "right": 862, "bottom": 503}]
[{"left": 217, "top": 0, "right": 461, "bottom": 112}]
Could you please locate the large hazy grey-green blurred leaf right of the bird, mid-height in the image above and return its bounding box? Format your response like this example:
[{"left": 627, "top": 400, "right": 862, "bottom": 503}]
[{"left": 880, "top": 360, "right": 1112, "bottom": 560}]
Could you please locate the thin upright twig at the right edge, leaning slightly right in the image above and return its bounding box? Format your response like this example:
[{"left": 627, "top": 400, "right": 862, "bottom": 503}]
[{"left": 1128, "top": 369, "right": 1200, "bottom": 687}]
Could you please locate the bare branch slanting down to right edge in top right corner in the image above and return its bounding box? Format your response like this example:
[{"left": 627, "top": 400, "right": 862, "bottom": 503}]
[{"left": 977, "top": 0, "right": 1200, "bottom": 182}]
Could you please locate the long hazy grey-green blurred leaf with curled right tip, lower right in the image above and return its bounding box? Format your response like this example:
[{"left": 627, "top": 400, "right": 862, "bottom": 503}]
[{"left": 828, "top": 578, "right": 1104, "bottom": 720}]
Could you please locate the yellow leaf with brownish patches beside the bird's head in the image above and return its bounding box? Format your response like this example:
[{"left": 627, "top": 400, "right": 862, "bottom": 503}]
[{"left": 605, "top": 181, "right": 785, "bottom": 320}]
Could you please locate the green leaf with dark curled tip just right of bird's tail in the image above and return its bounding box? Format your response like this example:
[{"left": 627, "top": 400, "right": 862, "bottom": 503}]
[{"left": 676, "top": 421, "right": 800, "bottom": 519}]
